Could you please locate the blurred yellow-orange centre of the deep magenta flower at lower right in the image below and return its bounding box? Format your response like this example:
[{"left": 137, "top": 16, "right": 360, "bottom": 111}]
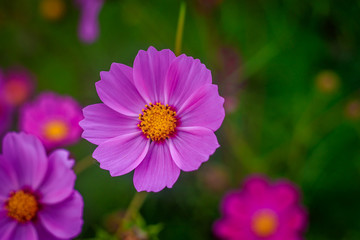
[{"left": 251, "top": 210, "right": 278, "bottom": 237}]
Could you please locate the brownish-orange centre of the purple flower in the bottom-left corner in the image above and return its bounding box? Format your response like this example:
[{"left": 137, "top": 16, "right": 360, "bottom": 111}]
[{"left": 5, "top": 190, "right": 39, "bottom": 223}]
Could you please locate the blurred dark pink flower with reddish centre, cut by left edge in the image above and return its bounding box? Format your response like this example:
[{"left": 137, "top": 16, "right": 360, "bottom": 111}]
[{"left": 0, "top": 68, "right": 34, "bottom": 106}]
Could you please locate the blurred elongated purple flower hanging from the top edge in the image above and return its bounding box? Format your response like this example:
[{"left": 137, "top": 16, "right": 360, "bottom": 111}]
[{"left": 75, "top": 0, "right": 104, "bottom": 44}]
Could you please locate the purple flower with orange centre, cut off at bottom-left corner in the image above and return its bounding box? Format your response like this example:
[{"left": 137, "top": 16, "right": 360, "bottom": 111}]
[{"left": 0, "top": 133, "right": 83, "bottom": 240}]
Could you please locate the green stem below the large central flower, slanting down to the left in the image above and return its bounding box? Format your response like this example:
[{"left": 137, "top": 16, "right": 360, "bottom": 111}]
[{"left": 115, "top": 192, "right": 148, "bottom": 239}]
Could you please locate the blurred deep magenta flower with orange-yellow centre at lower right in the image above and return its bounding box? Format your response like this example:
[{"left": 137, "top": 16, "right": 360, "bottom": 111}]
[{"left": 214, "top": 176, "right": 307, "bottom": 240}]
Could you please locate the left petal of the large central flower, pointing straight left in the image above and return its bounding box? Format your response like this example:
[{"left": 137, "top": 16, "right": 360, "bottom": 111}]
[{"left": 79, "top": 103, "right": 139, "bottom": 145}]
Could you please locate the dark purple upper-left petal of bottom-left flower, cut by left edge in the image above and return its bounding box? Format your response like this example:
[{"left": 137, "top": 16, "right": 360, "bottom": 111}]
[{"left": 0, "top": 155, "right": 19, "bottom": 199}]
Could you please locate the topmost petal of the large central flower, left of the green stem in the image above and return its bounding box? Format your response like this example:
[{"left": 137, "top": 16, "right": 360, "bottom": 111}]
[{"left": 134, "top": 47, "right": 176, "bottom": 103}]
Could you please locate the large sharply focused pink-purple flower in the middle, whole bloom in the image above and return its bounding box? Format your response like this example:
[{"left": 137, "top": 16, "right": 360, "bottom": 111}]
[{"left": 80, "top": 47, "right": 225, "bottom": 192}]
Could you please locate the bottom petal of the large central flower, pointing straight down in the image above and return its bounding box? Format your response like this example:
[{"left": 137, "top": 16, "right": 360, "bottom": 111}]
[{"left": 134, "top": 142, "right": 180, "bottom": 192}]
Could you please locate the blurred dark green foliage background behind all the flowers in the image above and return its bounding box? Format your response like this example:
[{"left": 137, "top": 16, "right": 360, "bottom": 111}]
[{"left": 0, "top": 0, "right": 360, "bottom": 240}]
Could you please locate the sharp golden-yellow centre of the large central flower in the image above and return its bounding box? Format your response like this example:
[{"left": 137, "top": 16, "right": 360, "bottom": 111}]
[{"left": 138, "top": 103, "right": 177, "bottom": 141}]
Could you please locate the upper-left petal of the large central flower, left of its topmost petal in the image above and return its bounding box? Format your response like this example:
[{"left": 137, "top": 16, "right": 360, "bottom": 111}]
[{"left": 96, "top": 63, "right": 147, "bottom": 117}]
